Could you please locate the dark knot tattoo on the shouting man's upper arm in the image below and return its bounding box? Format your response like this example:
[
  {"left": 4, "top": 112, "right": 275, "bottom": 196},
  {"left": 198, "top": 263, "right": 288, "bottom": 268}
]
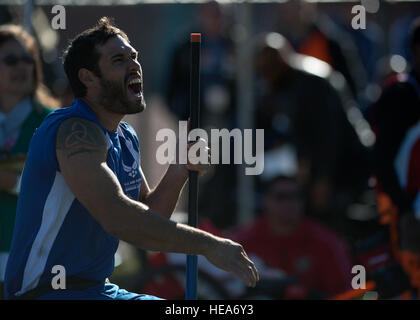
[{"left": 56, "top": 118, "right": 107, "bottom": 159}]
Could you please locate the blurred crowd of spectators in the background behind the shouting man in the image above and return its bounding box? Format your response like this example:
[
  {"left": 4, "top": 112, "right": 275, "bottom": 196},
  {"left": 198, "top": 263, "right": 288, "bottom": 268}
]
[{"left": 0, "top": 0, "right": 420, "bottom": 299}]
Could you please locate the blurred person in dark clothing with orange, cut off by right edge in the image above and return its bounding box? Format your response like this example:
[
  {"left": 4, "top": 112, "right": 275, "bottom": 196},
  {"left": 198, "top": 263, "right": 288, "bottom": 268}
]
[{"left": 369, "top": 18, "right": 420, "bottom": 299}]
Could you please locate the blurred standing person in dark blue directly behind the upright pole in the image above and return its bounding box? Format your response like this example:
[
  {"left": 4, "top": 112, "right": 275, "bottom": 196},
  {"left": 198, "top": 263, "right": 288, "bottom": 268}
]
[{"left": 166, "top": 1, "right": 237, "bottom": 228}]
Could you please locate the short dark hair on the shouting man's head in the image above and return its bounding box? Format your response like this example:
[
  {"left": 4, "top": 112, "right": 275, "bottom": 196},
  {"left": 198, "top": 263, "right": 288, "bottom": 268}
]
[{"left": 63, "top": 17, "right": 129, "bottom": 98}]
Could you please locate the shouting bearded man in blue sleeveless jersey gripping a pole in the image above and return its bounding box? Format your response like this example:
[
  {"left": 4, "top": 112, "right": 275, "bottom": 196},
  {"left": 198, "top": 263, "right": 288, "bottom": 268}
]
[{"left": 5, "top": 18, "right": 258, "bottom": 300}]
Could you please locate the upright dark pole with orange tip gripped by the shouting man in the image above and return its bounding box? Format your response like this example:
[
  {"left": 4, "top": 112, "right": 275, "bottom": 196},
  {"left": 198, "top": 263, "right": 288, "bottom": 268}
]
[{"left": 185, "top": 33, "right": 201, "bottom": 300}]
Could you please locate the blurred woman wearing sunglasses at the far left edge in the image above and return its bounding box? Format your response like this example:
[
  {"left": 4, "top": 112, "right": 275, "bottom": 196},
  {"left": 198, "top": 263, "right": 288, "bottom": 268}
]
[{"left": 0, "top": 25, "right": 57, "bottom": 299}]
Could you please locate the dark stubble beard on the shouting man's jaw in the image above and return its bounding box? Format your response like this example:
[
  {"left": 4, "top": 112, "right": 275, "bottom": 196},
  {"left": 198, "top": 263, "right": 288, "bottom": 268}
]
[{"left": 100, "top": 79, "right": 146, "bottom": 115}]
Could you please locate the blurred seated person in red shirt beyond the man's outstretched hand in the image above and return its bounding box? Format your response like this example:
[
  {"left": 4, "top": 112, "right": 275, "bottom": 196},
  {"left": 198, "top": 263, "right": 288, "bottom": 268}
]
[{"left": 233, "top": 171, "right": 352, "bottom": 298}]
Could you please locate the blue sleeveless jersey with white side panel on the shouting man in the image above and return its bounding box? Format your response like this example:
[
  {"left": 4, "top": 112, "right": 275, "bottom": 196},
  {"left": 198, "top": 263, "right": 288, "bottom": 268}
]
[{"left": 5, "top": 99, "right": 141, "bottom": 299}]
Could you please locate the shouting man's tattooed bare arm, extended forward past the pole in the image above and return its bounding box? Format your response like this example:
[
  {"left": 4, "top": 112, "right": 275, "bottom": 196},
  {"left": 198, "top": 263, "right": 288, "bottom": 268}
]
[{"left": 56, "top": 118, "right": 258, "bottom": 286}]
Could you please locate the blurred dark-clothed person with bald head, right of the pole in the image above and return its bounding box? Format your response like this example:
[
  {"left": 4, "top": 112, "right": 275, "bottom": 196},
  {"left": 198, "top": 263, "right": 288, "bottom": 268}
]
[{"left": 255, "top": 33, "right": 370, "bottom": 242}]
